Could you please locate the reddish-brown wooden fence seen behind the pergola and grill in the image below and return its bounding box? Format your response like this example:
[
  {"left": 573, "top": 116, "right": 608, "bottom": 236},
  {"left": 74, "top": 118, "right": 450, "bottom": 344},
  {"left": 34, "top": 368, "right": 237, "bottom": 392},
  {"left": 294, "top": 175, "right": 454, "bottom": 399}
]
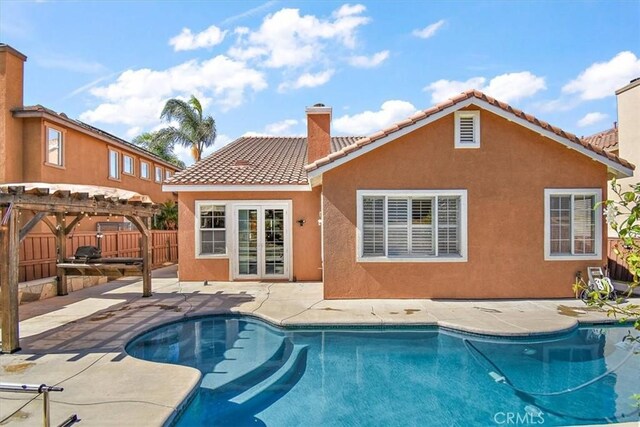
[{"left": 18, "top": 230, "right": 178, "bottom": 282}]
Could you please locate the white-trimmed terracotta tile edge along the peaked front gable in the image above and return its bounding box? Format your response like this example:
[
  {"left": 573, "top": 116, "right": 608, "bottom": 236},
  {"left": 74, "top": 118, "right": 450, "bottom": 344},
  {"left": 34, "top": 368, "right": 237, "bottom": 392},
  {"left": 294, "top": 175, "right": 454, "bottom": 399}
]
[{"left": 305, "top": 90, "right": 634, "bottom": 172}]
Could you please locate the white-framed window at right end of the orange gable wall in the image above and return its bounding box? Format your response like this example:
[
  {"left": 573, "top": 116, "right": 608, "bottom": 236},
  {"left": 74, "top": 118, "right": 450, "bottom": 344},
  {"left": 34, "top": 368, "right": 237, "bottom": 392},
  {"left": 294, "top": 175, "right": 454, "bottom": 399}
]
[{"left": 544, "top": 188, "right": 602, "bottom": 261}]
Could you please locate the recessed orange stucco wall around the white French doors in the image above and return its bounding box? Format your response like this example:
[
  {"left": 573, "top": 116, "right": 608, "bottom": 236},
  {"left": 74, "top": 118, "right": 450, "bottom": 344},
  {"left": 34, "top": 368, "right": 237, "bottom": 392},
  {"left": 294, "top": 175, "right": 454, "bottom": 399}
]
[{"left": 178, "top": 188, "right": 322, "bottom": 281}]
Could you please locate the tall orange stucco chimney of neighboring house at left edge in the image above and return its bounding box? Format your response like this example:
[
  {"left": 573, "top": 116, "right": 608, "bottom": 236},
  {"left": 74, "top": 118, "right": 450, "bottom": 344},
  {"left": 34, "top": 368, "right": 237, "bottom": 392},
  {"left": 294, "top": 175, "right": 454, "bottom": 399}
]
[{"left": 0, "top": 43, "right": 27, "bottom": 182}]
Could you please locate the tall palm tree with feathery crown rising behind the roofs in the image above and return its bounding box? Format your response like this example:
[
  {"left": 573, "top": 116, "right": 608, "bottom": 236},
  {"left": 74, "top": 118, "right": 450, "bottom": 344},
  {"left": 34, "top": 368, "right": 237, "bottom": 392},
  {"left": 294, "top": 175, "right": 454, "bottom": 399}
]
[{"left": 156, "top": 95, "right": 216, "bottom": 162}]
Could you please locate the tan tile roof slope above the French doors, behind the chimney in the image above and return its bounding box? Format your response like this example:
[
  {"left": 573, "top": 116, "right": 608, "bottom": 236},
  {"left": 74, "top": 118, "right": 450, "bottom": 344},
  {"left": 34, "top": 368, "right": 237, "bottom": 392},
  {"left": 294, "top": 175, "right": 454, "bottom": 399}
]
[{"left": 167, "top": 136, "right": 362, "bottom": 185}]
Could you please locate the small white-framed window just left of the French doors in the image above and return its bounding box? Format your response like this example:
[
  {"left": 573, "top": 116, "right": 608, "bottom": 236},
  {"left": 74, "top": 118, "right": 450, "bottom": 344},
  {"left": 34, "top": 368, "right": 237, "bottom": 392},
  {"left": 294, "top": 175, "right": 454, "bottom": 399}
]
[{"left": 196, "top": 202, "right": 228, "bottom": 258}]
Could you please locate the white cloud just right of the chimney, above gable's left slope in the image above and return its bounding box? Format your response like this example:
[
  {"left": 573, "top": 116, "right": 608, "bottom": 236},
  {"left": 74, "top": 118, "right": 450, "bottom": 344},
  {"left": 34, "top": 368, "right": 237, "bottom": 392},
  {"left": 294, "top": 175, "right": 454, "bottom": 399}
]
[{"left": 332, "top": 100, "right": 417, "bottom": 135}]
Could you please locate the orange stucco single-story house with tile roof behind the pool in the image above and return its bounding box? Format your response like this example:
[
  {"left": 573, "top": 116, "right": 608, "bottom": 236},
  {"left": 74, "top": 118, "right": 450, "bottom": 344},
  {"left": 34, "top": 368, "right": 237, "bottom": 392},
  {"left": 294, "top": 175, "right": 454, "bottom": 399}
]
[{"left": 164, "top": 91, "right": 634, "bottom": 299}]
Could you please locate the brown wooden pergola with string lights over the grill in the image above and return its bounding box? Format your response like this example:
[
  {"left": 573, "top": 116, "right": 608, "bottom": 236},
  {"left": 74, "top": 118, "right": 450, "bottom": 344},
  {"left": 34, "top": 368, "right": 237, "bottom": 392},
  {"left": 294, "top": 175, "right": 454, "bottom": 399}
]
[{"left": 0, "top": 184, "right": 157, "bottom": 353}]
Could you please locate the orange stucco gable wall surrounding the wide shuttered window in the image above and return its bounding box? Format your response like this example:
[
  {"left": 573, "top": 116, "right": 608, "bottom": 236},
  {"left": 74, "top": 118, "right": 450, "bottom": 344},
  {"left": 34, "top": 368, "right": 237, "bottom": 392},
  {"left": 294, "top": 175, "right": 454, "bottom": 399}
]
[{"left": 323, "top": 111, "right": 607, "bottom": 298}]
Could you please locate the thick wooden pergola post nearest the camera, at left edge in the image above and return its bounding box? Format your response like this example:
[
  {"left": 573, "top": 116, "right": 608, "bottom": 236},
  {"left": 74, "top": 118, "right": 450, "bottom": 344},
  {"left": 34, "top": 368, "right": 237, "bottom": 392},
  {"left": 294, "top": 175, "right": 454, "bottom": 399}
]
[{"left": 0, "top": 208, "right": 20, "bottom": 353}]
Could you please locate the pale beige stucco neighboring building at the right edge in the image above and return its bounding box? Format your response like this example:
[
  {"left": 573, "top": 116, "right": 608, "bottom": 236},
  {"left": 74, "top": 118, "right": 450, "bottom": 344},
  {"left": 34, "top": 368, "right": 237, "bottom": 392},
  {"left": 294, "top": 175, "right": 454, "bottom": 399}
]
[{"left": 616, "top": 77, "right": 640, "bottom": 171}]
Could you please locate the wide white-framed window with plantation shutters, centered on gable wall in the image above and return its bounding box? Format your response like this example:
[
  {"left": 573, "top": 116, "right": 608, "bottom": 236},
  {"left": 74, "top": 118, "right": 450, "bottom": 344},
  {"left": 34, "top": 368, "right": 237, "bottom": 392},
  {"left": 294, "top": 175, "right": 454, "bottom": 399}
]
[{"left": 356, "top": 190, "right": 467, "bottom": 262}]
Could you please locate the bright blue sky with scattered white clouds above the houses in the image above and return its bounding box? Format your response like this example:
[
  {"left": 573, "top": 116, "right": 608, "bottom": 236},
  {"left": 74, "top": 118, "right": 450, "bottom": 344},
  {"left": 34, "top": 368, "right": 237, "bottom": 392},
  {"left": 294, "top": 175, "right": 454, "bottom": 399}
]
[{"left": 0, "top": 0, "right": 640, "bottom": 166}]
